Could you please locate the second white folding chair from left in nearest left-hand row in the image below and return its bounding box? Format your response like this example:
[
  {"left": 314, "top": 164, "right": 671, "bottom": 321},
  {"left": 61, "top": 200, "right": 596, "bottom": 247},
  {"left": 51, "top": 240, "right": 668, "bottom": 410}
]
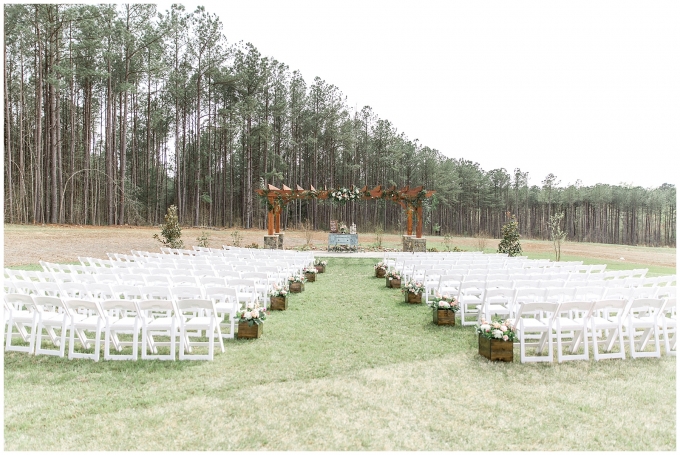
[{"left": 32, "top": 296, "right": 70, "bottom": 357}]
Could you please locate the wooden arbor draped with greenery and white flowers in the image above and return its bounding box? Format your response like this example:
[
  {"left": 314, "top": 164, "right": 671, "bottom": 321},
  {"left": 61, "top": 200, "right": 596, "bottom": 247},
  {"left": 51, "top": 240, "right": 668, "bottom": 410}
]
[{"left": 256, "top": 185, "right": 435, "bottom": 238}]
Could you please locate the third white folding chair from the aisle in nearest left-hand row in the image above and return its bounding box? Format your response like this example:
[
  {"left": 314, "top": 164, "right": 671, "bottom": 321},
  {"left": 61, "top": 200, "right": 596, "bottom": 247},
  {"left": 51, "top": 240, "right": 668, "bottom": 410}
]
[{"left": 100, "top": 299, "right": 142, "bottom": 360}]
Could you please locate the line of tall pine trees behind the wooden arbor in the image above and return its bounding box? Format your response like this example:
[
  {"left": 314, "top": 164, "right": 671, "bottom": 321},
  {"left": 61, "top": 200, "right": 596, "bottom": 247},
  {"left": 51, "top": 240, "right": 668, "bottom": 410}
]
[{"left": 4, "top": 4, "right": 676, "bottom": 246}]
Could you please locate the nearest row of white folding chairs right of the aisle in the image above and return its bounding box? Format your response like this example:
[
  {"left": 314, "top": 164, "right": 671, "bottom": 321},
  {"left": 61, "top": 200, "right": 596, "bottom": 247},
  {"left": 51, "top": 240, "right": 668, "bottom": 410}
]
[{"left": 515, "top": 298, "right": 677, "bottom": 363}]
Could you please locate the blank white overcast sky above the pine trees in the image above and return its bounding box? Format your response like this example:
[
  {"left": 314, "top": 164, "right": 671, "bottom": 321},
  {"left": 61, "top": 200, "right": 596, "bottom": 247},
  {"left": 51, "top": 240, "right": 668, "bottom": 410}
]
[{"left": 165, "top": 0, "right": 680, "bottom": 187}]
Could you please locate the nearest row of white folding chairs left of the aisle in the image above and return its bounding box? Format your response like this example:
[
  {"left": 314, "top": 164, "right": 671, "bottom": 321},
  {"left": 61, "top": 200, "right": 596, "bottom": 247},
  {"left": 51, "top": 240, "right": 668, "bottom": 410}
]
[{"left": 5, "top": 294, "right": 224, "bottom": 361}]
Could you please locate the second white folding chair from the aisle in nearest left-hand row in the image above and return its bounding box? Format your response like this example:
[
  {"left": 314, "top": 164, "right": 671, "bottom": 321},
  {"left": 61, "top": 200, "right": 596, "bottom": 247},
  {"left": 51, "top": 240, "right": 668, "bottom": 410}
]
[{"left": 138, "top": 299, "right": 179, "bottom": 360}]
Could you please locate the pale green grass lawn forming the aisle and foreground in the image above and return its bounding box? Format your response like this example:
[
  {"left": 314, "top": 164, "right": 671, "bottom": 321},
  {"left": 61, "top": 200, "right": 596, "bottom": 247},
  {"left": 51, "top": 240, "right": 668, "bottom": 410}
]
[{"left": 4, "top": 258, "right": 676, "bottom": 451}]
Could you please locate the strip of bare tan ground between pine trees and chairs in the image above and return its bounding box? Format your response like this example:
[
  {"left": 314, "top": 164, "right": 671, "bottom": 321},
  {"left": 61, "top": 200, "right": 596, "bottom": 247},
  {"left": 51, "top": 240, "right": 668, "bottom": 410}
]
[{"left": 4, "top": 224, "right": 676, "bottom": 267}]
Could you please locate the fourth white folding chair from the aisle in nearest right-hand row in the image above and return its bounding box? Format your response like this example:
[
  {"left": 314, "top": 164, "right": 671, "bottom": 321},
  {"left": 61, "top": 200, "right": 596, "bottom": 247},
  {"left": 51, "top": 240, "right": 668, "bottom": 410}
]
[{"left": 622, "top": 299, "right": 664, "bottom": 359}]
